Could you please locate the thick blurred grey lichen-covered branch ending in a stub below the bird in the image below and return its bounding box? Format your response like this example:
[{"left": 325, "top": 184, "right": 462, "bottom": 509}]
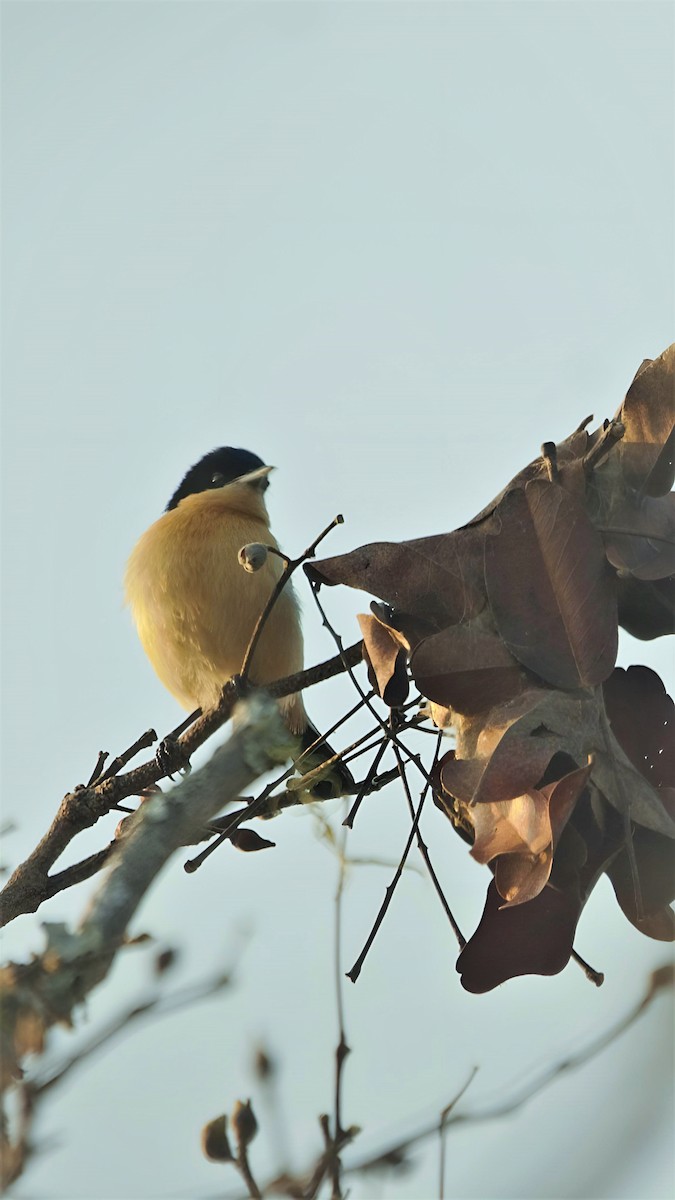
[{"left": 0, "top": 694, "right": 294, "bottom": 1195}]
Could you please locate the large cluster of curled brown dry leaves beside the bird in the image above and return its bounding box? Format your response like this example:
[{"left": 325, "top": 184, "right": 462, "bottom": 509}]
[{"left": 306, "top": 347, "right": 675, "bottom": 991}]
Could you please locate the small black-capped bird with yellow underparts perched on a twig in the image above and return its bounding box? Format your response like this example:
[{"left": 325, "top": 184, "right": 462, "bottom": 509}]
[{"left": 125, "top": 446, "right": 354, "bottom": 799}]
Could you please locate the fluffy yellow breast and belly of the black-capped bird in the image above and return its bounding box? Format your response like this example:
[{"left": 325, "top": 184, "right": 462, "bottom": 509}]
[{"left": 125, "top": 492, "right": 304, "bottom": 728}]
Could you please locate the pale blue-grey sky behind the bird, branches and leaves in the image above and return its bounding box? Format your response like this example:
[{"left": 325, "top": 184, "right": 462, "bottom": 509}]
[{"left": 2, "top": 7, "right": 675, "bottom": 1200}]
